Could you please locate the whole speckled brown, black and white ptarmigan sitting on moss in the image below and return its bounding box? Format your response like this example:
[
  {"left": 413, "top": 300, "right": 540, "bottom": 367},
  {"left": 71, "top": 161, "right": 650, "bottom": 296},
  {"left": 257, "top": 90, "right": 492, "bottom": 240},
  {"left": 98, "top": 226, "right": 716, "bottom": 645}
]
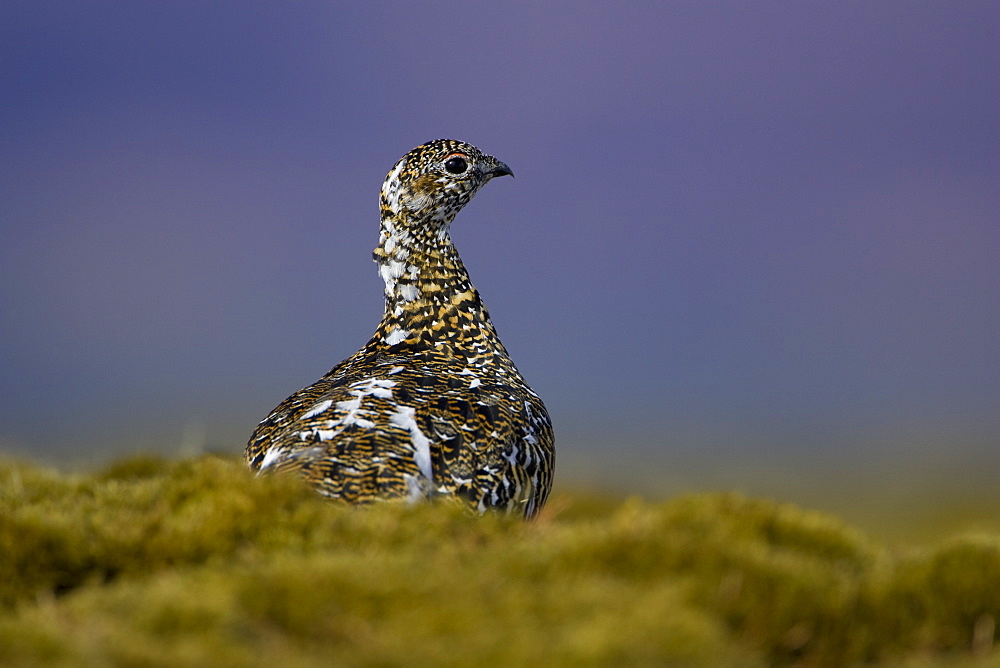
[{"left": 246, "top": 139, "right": 555, "bottom": 517}]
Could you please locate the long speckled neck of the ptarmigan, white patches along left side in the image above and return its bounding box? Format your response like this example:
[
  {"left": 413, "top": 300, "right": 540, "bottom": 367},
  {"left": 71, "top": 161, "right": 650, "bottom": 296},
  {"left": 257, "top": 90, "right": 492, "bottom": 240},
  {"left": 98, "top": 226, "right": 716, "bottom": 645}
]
[{"left": 372, "top": 216, "right": 503, "bottom": 355}]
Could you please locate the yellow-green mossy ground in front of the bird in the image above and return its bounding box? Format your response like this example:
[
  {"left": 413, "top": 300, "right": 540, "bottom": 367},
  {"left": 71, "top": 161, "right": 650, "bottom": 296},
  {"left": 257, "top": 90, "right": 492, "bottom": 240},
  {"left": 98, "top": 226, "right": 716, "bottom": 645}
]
[{"left": 0, "top": 457, "right": 1000, "bottom": 666}]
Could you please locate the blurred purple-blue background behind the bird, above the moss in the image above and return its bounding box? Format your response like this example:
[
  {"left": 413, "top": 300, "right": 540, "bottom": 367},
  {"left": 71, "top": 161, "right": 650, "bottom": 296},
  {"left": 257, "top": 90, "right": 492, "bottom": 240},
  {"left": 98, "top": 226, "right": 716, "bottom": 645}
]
[{"left": 0, "top": 1, "right": 1000, "bottom": 522}]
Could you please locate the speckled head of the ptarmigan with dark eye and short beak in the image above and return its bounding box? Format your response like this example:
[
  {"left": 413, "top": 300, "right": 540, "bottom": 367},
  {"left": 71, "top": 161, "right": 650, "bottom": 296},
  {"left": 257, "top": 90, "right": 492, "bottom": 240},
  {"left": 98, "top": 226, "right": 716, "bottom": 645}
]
[{"left": 381, "top": 139, "right": 514, "bottom": 227}]
